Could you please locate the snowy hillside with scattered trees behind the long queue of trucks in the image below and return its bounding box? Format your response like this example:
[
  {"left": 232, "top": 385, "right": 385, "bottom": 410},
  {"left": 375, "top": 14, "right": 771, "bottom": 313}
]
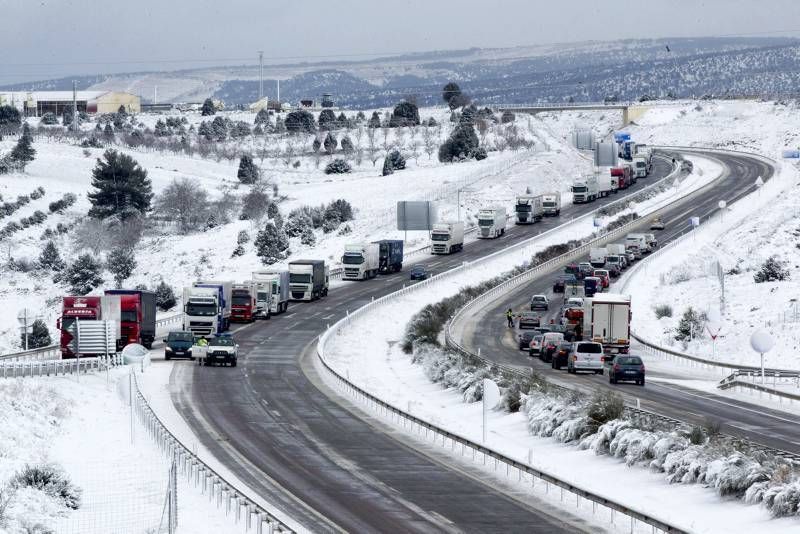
[{"left": 0, "top": 108, "right": 616, "bottom": 354}]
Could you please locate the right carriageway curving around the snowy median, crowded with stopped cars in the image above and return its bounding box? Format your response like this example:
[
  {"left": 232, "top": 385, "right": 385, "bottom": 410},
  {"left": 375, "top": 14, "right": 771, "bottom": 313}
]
[{"left": 462, "top": 151, "right": 800, "bottom": 453}]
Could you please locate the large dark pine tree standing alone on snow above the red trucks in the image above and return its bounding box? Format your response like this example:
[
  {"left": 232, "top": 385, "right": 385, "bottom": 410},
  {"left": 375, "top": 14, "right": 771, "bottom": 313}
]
[{"left": 88, "top": 150, "right": 153, "bottom": 220}]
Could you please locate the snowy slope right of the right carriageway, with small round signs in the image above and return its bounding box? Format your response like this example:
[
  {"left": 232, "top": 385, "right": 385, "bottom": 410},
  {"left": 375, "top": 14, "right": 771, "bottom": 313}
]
[{"left": 624, "top": 151, "right": 800, "bottom": 369}]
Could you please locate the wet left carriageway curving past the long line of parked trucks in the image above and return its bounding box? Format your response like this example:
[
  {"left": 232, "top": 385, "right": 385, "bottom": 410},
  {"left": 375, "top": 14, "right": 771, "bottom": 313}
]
[{"left": 170, "top": 154, "right": 671, "bottom": 533}]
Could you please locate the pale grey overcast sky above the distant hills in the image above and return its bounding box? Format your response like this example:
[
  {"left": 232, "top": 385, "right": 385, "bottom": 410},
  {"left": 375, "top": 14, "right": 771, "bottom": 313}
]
[{"left": 0, "top": 0, "right": 800, "bottom": 85}]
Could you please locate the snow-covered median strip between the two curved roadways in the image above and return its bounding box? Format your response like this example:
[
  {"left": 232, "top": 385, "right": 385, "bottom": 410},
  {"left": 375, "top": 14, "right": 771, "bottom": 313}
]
[{"left": 318, "top": 158, "right": 776, "bottom": 533}]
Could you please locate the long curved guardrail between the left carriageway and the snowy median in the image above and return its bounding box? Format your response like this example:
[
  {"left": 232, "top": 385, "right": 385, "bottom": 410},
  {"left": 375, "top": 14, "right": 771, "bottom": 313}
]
[{"left": 317, "top": 155, "right": 683, "bottom": 532}]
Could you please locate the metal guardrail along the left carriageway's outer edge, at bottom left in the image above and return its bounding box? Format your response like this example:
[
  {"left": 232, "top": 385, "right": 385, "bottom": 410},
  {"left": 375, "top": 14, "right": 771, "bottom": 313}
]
[{"left": 128, "top": 369, "right": 293, "bottom": 534}]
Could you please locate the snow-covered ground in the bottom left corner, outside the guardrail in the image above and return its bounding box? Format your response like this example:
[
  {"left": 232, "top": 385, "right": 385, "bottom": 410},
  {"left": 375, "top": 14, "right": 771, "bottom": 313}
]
[{"left": 0, "top": 368, "right": 241, "bottom": 534}]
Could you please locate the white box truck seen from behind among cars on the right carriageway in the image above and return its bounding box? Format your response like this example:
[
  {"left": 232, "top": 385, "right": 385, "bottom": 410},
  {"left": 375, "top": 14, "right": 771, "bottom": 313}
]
[{"left": 582, "top": 293, "right": 631, "bottom": 354}]
